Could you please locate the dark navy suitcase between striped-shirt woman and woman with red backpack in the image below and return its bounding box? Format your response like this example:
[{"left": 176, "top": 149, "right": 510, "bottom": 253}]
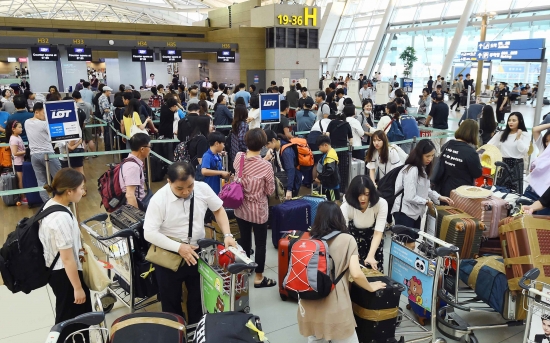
[{"left": 269, "top": 199, "right": 311, "bottom": 248}]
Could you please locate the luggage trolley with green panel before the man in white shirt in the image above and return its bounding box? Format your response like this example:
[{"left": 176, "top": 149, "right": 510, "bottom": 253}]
[{"left": 197, "top": 239, "right": 258, "bottom": 313}]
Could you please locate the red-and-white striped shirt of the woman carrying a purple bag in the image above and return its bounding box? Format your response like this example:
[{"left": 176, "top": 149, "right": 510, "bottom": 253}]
[{"left": 233, "top": 152, "right": 275, "bottom": 224}]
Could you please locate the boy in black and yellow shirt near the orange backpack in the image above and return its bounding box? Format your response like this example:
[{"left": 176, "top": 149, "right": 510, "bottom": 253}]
[{"left": 315, "top": 135, "right": 340, "bottom": 201}]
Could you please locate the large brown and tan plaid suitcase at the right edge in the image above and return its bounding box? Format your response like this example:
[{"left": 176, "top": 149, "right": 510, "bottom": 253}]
[{"left": 498, "top": 215, "right": 550, "bottom": 291}]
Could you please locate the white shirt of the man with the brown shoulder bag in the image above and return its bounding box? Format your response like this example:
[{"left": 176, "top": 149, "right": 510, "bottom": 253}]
[{"left": 143, "top": 181, "right": 223, "bottom": 252}]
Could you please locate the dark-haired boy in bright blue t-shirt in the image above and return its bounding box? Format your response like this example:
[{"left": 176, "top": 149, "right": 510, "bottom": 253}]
[{"left": 201, "top": 132, "right": 229, "bottom": 194}]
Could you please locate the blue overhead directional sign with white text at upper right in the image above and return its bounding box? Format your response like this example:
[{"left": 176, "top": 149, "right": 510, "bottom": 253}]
[{"left": 476, "top": 38, "right": 546, "bottom": 61}]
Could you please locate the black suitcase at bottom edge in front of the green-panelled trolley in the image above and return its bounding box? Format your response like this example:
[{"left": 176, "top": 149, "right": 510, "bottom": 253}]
[{"left": 192, "top": 312, "right": 263, "bottom": 343}]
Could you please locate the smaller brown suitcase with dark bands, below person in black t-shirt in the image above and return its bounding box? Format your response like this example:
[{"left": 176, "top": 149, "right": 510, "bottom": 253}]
[{"left": 429, "top": 206, "right": 485, "bottom": 258}]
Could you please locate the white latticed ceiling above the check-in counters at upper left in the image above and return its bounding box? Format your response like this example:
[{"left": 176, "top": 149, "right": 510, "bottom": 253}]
[{"left": 0, "top": 0, "right": 248, "bottom": 25}]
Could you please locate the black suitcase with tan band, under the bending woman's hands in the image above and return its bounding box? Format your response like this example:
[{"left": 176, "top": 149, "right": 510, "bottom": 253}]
[{"left": 350, "top": 269, "right": 405, "bottom": 343}]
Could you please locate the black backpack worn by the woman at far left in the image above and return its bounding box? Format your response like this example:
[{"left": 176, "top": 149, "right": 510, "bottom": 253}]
[{"left": 0, "top": 204, "right": 73, "bottom": 294}]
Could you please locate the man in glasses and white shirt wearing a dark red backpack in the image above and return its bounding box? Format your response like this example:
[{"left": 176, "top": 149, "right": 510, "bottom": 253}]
[{"left": 118, "top": 133, "right": 153, "bottom": 211}]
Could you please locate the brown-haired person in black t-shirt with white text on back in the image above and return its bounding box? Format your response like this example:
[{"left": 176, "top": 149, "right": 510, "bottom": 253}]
[{"left": 439, "top": 120, "right": 484, "bottom": 197}]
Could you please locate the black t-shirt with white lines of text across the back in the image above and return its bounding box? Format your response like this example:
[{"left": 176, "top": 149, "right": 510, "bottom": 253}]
[{"left": 441, "top": 140, "right": 481, "bottom": 197}]
